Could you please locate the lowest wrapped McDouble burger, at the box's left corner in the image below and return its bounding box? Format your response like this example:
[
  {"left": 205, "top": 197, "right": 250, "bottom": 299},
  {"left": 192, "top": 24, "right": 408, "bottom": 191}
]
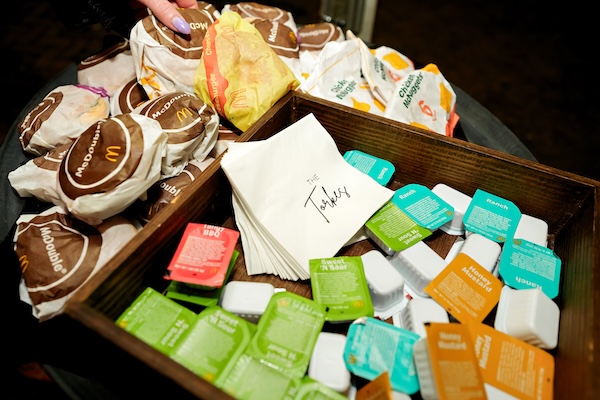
[{"left": 13, "top": 206, "right": 137, "bottom": 321}]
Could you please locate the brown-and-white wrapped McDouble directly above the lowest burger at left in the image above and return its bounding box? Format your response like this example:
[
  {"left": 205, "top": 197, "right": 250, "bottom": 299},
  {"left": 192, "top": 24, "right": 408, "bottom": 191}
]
[{"left": 58, "top": 113, "right": 167, "bottom": 225}]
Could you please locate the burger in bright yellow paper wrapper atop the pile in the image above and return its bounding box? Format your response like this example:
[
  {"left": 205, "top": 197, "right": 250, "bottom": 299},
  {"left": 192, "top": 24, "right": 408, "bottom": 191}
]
[{"left": 194, "top": 11, "right": 300, "bottom": 132}]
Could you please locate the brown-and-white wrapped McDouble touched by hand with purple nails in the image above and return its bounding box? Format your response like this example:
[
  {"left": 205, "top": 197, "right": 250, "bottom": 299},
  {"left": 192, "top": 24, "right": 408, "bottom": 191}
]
[{"left": 129, "top": 8, "right": 217, "bottom": 100}]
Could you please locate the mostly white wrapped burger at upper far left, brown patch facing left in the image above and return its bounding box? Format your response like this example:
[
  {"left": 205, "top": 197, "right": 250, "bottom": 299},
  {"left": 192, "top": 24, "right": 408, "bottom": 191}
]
[{"left": 18, "top": 85, "right": 109, "bottom": 156}]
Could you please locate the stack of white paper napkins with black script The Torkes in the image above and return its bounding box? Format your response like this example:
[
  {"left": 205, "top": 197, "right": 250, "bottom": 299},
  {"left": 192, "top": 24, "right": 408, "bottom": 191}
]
[{"left": 221, "top": 114, "right": 393, "bottom": 280}]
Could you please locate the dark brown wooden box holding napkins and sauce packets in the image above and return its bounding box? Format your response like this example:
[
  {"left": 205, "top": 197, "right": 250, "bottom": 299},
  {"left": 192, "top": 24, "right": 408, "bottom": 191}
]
[{"left": 64, "top": 93, "right": 600, "bottom": 399}]
